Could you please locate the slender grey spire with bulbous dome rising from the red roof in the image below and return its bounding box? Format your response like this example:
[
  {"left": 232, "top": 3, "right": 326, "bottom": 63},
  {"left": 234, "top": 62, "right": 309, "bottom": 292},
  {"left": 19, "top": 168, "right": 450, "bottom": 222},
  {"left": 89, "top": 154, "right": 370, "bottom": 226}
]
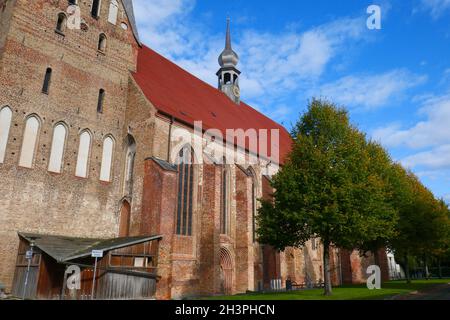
[{"left": 217, "top": 18, "right": 241, "bottom": 104}]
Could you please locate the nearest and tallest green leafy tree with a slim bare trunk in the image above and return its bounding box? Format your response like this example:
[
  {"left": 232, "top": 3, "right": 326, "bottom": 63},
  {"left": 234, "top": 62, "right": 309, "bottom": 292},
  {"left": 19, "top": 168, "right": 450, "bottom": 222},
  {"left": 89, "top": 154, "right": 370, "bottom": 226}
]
[{"left": 258, "top": 100, "right": 396, "bottom": 295}]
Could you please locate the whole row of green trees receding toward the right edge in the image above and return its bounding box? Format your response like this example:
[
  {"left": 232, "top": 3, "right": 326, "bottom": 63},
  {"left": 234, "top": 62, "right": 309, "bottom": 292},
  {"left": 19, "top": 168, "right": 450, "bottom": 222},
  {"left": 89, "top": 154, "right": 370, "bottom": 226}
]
[{"left": 257, "top": 99, "right": 450, "bottom": 295}]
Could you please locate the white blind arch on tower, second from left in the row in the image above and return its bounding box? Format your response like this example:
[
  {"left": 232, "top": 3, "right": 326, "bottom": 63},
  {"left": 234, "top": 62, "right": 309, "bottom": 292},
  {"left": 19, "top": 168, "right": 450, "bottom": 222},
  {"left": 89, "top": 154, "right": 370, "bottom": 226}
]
[{"left": 19, "top": 115, "right": 41, "bottom": 168}]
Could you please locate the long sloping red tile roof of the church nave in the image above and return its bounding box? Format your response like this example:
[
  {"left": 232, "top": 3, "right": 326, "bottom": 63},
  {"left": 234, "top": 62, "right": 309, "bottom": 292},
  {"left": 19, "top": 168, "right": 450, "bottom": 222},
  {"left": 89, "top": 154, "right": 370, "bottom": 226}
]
[{"left": 133, "top": 46, "right": 292, "bottom": 163}]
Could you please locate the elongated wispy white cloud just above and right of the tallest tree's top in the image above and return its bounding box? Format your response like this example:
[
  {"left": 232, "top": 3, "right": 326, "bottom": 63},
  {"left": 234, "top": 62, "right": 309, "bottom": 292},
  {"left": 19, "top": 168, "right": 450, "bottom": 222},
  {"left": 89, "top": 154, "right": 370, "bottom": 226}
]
[{"left": 310, "top": 70, "right": 426, "bottom": 109}]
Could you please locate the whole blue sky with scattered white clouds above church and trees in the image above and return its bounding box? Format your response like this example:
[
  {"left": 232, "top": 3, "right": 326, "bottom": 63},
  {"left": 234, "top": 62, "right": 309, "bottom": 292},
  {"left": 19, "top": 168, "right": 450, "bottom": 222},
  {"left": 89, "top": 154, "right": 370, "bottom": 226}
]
[{"left": 134, "top": 0, "right": 450, "bottom": 202}]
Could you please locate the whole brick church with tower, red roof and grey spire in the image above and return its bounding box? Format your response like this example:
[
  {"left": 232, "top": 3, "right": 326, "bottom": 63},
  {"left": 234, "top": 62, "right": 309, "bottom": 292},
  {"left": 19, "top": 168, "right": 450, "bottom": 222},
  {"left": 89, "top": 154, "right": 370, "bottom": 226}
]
[{"left": 0, "top": 0, "right": 387, "bottom": 299}]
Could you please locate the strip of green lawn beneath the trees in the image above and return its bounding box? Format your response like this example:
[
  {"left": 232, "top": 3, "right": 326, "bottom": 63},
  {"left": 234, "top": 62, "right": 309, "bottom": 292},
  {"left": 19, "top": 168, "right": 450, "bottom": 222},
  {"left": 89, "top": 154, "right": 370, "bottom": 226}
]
[{"left": 203, "top": 279, "right": 450, "bottom": 300}]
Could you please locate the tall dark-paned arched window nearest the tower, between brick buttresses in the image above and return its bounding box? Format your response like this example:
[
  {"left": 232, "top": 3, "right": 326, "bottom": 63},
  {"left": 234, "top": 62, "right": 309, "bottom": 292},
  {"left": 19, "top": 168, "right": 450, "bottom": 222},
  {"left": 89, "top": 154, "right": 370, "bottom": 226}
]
[{"left": 176, "top": 145, "right": 194, "bottom": 236}]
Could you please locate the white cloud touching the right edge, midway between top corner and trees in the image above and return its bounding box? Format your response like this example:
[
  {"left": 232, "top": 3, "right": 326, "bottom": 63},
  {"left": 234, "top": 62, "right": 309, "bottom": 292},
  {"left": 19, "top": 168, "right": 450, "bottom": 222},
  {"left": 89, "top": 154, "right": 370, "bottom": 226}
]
[{"left": 373, "top": 94, "right": 450, "bottom": 149}]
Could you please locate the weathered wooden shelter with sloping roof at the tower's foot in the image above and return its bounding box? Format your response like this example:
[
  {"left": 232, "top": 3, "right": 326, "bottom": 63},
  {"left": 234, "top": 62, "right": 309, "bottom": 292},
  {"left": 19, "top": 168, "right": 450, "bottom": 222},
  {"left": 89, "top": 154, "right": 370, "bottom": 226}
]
[{"left": 13, "top": 233, "right": 162, "bottom": 300}]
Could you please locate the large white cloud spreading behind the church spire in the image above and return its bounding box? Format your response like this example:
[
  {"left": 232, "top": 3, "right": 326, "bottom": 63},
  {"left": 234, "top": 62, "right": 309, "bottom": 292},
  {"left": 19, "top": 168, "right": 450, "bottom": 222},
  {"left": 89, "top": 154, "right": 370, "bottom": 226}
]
[{"left": 131, "top": 0, "right": 368, "bottom": 121}]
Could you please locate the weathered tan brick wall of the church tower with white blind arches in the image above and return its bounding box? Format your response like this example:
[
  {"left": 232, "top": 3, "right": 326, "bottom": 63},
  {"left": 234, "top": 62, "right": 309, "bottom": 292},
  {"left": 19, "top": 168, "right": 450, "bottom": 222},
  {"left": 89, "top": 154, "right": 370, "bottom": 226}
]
[{"left": 0, "top": 0, "right": 137, "bottom": 287}]
